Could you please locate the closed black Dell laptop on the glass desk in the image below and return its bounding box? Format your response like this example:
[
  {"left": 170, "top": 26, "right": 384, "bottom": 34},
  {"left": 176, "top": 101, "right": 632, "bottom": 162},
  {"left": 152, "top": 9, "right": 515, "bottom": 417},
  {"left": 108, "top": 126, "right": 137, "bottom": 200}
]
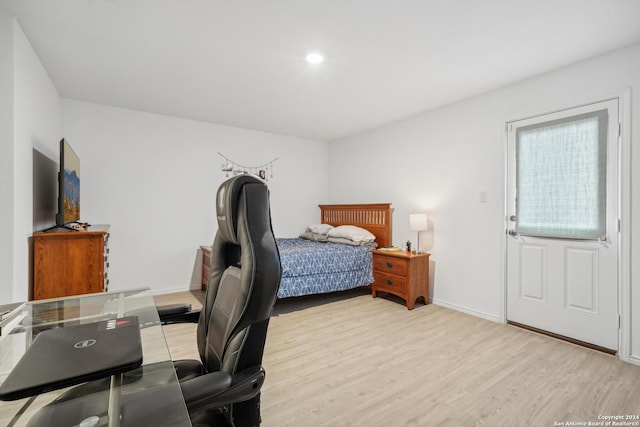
[{"left": 0, "top": 316, "right": 142, "bottom": 400}]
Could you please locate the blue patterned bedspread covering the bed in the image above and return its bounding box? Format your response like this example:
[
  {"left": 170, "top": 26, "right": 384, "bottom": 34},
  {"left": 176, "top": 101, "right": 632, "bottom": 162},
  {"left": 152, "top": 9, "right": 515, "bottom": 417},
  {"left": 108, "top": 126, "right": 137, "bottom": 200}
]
[{"left": 276, "top": 238, "right": 373, "bottom": 298}]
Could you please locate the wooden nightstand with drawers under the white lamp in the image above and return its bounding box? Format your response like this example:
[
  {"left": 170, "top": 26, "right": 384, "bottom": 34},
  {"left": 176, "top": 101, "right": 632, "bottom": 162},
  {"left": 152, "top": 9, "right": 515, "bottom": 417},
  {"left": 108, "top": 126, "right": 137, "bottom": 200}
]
[{"left": 371, "top": 250, "right": 429, "bottom": 310}]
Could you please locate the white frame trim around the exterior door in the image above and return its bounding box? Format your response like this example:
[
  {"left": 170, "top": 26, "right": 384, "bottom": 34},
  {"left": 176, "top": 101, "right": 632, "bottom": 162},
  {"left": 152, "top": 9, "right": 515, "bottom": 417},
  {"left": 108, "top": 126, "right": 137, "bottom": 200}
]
[{"left": 500, "top": 88, "right": 640, "bottom": 365}]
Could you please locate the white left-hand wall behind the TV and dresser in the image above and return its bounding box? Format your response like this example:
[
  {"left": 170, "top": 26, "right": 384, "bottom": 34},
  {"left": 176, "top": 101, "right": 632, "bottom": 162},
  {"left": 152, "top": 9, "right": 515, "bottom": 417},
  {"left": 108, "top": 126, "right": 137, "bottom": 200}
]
[{"left": 0, "top": 15, "right": 60, "bottom": 302}]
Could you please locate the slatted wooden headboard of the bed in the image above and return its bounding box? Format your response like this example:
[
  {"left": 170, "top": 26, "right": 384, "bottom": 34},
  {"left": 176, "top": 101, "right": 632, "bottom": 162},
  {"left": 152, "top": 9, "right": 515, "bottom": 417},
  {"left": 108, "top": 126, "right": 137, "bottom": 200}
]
[{"left": 318, "top": 203, "right": 393, "bottom": 248}]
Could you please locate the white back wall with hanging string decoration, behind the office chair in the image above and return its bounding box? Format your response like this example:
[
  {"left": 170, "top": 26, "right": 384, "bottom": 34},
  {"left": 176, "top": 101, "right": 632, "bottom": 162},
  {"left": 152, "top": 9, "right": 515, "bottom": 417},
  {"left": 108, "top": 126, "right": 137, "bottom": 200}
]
[{"left": 62, "top": 100, "right": 328, "bottom": 292}]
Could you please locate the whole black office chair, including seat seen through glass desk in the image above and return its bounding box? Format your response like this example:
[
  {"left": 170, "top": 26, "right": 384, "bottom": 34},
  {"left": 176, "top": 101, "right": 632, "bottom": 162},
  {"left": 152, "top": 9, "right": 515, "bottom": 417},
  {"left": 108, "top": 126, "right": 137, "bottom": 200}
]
[{"left": 29, "top": 175, "right": 282, "bottom": 427}]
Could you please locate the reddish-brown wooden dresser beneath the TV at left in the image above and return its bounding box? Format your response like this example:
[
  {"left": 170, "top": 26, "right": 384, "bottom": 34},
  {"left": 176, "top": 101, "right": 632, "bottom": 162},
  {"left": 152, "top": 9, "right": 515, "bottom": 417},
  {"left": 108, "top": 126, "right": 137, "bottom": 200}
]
[{"left": 31, "top": 225, "right": 109, "bottom": 300}]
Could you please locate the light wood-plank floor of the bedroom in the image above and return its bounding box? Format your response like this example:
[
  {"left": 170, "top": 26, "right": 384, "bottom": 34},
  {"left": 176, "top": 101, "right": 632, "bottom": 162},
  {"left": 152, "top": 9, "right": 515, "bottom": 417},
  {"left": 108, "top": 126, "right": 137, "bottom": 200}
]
[{"left": 155, "top": 289, "right": 640, "bottom": 427}]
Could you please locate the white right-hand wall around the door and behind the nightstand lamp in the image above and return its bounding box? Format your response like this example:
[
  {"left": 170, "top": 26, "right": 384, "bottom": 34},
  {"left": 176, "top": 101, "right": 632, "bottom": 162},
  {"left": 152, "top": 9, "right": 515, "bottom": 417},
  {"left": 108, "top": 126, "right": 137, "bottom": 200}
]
[{"left": 329, "top": 45, "right": 640, "bottom": 361}]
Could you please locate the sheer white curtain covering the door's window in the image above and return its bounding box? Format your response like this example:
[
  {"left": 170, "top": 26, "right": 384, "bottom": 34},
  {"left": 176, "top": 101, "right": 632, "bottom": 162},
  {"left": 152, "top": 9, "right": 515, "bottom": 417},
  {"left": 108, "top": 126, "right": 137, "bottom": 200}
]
[{"left": 515, "top": 110, "right": 608, "bottom": 240}]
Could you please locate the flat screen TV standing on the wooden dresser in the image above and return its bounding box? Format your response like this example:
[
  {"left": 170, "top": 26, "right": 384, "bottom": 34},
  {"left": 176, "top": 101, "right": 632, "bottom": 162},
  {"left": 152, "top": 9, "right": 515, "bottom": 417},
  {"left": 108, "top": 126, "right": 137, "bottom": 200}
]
[{"left": 56, "top": 138, "right": 80, "bottom": 227}]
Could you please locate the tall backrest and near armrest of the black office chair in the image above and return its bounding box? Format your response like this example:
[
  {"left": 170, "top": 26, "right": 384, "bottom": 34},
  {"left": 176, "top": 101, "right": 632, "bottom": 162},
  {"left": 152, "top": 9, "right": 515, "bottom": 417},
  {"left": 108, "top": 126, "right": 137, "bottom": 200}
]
[{"left": 169, "top": 175, "right": 282, "bottom": 426}]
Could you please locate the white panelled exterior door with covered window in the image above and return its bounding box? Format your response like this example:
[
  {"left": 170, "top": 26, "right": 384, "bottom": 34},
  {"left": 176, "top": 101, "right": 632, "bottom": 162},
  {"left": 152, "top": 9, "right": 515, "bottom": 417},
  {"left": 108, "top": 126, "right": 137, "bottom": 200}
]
[{"left": 506, "top": 99, "right": 619, "bottom": 350}]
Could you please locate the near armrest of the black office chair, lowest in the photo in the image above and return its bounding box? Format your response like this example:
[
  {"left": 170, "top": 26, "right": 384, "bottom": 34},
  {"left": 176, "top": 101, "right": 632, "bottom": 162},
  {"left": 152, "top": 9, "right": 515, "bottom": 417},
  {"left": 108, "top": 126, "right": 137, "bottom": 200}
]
[{"left": 180, "top": 366, "right": 265, "bottom": 411}]
